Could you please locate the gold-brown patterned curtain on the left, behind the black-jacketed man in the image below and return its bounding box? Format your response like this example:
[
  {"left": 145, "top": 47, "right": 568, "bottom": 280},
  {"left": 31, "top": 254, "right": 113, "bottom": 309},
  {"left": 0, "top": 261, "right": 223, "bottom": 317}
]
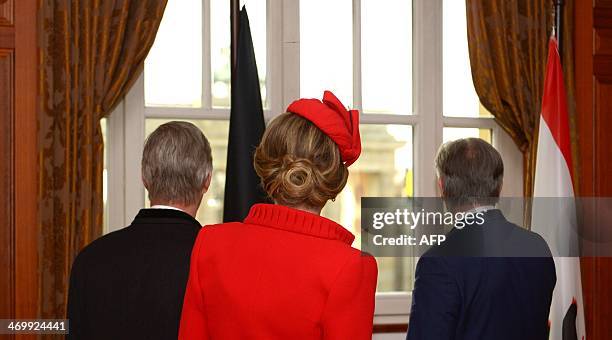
[{"left": 38, "top": 0, "right": 167, "bottom": 324}]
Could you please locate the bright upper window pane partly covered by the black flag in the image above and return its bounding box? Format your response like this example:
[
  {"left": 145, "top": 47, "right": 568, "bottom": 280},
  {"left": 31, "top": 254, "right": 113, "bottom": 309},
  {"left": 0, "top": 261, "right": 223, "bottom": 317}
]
[{"left": 210, "top": 0, "right": 267, "bottom": 107}]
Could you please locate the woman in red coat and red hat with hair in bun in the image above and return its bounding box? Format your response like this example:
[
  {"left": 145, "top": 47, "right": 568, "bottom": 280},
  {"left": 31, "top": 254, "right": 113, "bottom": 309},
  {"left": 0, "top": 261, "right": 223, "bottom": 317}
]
[{"left": 179, "top": 92, "right": 377, "bottom": 340}]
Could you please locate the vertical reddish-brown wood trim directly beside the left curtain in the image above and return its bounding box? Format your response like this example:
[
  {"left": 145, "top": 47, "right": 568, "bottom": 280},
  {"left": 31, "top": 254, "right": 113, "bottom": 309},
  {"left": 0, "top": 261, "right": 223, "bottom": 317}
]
[{"left": 14, "top": 0, "right": 40, "bottom": 330}]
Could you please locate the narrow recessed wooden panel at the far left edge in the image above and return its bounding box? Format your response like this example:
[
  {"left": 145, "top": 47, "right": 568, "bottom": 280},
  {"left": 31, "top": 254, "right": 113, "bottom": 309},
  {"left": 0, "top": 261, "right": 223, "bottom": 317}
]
[{"left": 0, "top": 48, "right": 15, "bottom": 319}]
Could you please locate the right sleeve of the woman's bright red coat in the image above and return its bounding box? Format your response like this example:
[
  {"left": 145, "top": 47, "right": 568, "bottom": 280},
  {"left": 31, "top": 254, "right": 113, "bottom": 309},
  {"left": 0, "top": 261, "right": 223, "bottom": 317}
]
[{"left": 322, "top": 255, "right": 378, "bottom": 340}]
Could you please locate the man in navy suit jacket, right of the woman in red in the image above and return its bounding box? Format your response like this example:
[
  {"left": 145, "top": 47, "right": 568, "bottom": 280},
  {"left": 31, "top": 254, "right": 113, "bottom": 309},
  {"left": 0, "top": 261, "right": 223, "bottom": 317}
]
[{"left": 407, "top": 138, "right": 556, "bottom": 340}]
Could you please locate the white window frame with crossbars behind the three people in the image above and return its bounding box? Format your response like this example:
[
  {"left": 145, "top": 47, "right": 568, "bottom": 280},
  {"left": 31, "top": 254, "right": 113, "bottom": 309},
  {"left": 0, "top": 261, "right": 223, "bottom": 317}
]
[{"left": 105, "top": 0, "right": 523, "bottom": 324}]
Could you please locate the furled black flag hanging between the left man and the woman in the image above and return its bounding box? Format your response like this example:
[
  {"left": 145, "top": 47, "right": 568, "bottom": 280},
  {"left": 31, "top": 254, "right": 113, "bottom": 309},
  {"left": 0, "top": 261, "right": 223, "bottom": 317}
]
[{"left": 223, "top": 7, "right": 266, "bottom": 222}]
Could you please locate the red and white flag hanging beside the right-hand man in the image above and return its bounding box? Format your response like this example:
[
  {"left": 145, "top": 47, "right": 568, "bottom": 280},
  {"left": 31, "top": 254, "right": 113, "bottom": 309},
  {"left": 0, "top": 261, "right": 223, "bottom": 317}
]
[{"left": 531, "top": 37, "right": 586, "bottom": 340}]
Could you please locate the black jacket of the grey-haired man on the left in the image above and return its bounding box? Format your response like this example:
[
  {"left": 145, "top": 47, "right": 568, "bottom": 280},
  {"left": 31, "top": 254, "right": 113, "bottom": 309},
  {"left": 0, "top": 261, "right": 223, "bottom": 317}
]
[{"left": 67, "top": 209, "right": 201, "bottom": 340}]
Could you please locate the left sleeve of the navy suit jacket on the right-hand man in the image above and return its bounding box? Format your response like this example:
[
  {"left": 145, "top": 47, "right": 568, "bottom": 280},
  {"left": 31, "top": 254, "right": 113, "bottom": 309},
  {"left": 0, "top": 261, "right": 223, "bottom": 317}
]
[{"left": 407, "top": 257, "right": 461, "bottom": 340}]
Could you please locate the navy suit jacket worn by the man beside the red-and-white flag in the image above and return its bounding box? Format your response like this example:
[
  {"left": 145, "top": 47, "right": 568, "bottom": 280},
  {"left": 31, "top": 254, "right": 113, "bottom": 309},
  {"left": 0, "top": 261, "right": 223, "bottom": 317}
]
[{"left": 407, "top": 209, "right": 556, "bottom": 340}]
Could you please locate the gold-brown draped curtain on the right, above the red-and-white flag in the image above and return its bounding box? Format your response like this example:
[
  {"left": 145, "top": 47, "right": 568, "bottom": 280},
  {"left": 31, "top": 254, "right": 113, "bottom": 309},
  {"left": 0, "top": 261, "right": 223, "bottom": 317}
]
[{"left": 466, "top": 0, "right": 574, "bottom": 197}]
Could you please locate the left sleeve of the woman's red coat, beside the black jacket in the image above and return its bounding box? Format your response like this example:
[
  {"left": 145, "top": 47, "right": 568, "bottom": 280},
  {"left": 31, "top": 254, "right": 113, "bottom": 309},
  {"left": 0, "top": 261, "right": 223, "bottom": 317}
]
[{"left": 179, "top": 230, "right": 209, "bottom": 340}]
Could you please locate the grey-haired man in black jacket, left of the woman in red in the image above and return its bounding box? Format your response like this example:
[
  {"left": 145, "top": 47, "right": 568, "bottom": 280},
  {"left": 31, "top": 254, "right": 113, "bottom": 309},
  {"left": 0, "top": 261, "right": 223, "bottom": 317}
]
[{"left": 67, "top": 122, "right": 212, "bottom": 340}]
